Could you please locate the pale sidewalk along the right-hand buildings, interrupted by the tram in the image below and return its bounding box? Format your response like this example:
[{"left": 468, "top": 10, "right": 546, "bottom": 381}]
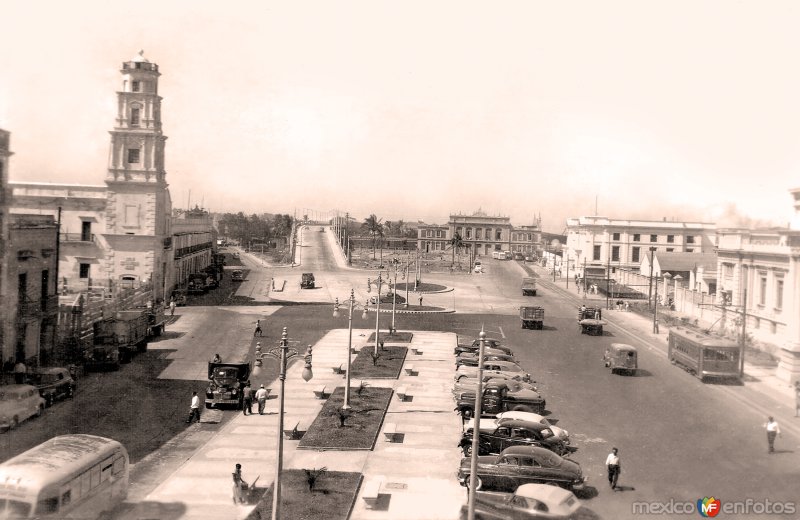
[{"left": 528, "top": 265, "right": 800, "bottom": 436}]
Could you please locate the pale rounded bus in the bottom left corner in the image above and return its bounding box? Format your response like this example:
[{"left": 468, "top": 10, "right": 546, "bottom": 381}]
[{"left": 0, "top": 434, "right": 129, "bottom": 519}]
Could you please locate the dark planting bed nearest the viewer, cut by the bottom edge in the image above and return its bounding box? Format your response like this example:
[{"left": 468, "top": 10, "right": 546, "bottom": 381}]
[{"left": 247, "top": 468, "right": 361, "bottom": 520}]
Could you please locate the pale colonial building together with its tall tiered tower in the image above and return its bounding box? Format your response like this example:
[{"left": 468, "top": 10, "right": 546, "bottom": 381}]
[{"left": 6, "top": 52, "right": 205, "bottom": 300}]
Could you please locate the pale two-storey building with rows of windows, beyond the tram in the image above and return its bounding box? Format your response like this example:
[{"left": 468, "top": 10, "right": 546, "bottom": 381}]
[{"left": 564, "top": 216, "right": 716, "bottom": 278}]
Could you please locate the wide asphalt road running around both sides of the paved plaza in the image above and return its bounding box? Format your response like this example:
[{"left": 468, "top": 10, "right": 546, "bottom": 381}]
[{"left": 2, "top": 226, "right": 800, "bottom": 519}]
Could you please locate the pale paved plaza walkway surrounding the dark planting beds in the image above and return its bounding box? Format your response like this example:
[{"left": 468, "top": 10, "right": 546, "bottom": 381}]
[{"left": 121, "top": 329, "right": 466, "bottom": 520}]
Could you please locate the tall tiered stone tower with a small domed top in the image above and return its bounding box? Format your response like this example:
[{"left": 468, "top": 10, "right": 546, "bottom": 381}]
[{"left": 103, "top": 51, "right": 172, "bottom": 299}]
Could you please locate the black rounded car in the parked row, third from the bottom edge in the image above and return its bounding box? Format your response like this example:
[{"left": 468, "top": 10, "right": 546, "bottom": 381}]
[{"left": 459, "top": 419, "right": 577, "bottom": 456}]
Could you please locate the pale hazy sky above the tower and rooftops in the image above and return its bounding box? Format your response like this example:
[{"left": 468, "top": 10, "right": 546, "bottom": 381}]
[{"left": 0, "top": 0, "right": 800, "bottom": 233}]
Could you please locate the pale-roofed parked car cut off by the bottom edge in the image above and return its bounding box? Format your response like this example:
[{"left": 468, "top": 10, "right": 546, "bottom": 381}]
[{"left": 461, "top": 484, "right": 592, "bottom": 520}]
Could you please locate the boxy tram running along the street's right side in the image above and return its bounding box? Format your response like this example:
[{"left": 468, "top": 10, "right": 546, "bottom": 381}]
[{"left": 667, "top": 327, "right": 741, "bottom": 382}]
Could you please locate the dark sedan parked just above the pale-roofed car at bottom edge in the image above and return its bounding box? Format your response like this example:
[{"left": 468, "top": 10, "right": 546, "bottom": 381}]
[{"left": 458, "top": 446, "right": 587, "bottom": 493}]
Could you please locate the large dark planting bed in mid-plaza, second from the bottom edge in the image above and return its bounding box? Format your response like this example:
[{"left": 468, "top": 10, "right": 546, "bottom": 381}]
[{"left": 296, "top": 384, "right": 393, "bottom": 450}]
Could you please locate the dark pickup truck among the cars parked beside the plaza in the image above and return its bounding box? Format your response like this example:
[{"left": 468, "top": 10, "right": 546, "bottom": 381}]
[{"left": 456, "top": 379, "right": 547, "bottom": 419}]
